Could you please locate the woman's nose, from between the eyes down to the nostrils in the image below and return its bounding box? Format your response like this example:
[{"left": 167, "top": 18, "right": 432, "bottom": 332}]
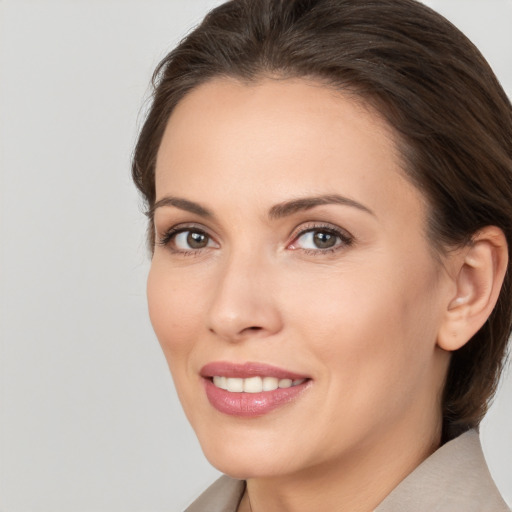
[{"left": 208, "top": 250, "right": 282, "bottom": 342}]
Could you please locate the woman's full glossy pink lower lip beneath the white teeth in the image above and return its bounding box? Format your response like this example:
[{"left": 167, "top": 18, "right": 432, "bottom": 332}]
[{"left": 204, "top": 379, "right": 310, "bottom": 418}]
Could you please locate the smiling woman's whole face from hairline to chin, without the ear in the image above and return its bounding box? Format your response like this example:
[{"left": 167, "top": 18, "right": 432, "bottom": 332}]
[{"left": 148, "top": 79, "right": 454, "bottom": 478}]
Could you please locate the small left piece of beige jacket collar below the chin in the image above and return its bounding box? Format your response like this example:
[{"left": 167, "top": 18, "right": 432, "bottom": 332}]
[{"left": 185, "top": 475, "right": 245, "bottom": 512}]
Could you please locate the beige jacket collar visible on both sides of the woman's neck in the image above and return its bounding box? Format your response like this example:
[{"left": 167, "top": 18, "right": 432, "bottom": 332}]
[{"left": 185, "top": 430, "right": 510, "bottom": 512}]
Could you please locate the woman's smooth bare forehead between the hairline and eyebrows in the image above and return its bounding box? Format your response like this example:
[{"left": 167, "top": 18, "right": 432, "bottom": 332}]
[{"left": 156, "top": 78, "right": 422, "bottom": 220}]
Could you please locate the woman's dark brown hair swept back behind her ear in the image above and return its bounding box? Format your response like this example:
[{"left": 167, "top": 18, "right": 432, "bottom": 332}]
[{"left": 132, "top": 0, "right": 512, "bottom": 440}]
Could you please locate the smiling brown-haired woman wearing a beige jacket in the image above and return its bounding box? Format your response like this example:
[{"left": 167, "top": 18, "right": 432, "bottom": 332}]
[{"left": 133, "top": 0, "right": 512, "bottom": 512}]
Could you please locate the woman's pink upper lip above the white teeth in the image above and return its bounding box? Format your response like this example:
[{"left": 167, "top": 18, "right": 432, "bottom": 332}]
[{"left": 200, "top": 361, "right": 309, "bottom": 380}]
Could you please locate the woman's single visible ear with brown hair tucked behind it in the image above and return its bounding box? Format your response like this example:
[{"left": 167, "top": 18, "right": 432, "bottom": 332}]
[{"left": 437, "top": 226, "right": 508, "bottom": 351}]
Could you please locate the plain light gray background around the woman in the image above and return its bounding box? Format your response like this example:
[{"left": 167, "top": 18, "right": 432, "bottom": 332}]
[{"left": 0, "top": 0, "right": 512, "bottom": 512}]
